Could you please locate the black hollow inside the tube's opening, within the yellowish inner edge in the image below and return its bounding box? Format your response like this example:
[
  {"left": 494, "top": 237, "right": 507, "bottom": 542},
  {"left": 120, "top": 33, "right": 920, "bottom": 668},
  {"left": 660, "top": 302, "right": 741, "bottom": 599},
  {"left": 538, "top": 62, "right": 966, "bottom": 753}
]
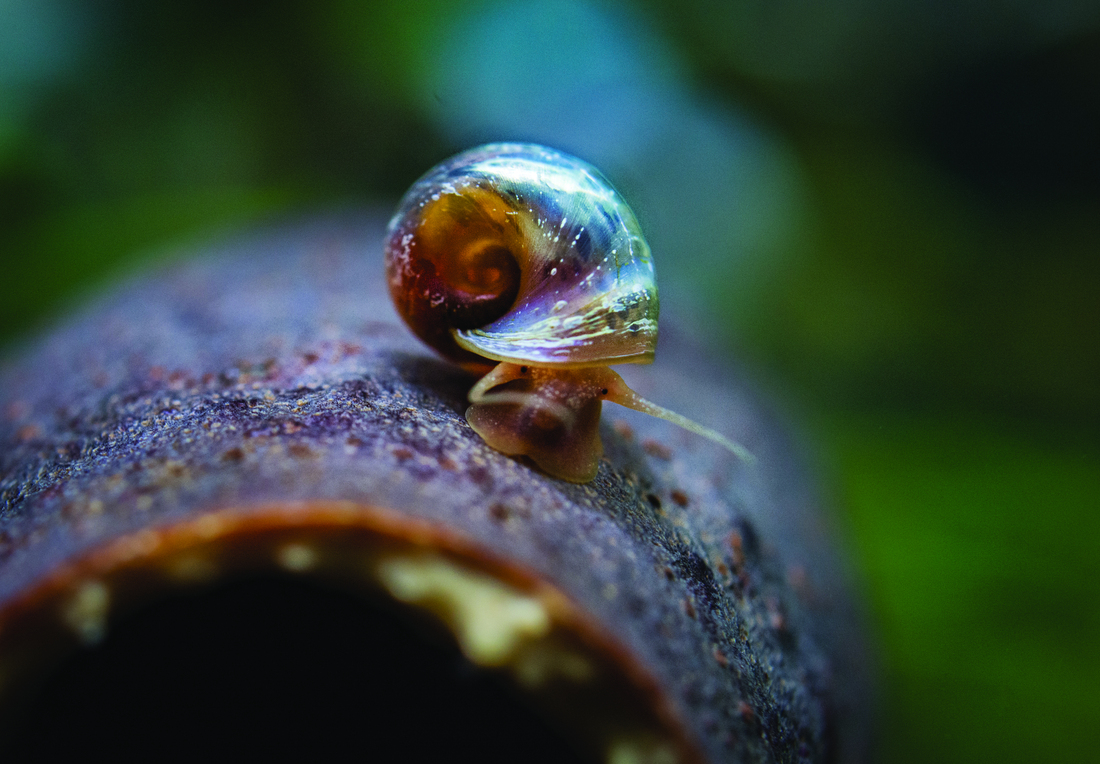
[{"left": 3, "top": 574, "right": 585, "bottom": 763}]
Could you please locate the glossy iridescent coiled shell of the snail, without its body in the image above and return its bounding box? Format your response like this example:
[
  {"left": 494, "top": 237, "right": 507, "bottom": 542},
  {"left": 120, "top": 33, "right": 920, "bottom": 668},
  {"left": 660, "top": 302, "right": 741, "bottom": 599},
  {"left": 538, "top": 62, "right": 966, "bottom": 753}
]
[{"left": 385, "top": 143, "right": 658, "bottom": 367}]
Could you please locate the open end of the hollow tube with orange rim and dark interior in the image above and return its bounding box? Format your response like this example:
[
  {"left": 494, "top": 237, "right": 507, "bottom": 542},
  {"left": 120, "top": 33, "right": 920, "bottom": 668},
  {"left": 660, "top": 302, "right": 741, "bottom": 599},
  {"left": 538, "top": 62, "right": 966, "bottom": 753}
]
[{"left": 0, "top": 503, "right": 693, "bottom": 762}]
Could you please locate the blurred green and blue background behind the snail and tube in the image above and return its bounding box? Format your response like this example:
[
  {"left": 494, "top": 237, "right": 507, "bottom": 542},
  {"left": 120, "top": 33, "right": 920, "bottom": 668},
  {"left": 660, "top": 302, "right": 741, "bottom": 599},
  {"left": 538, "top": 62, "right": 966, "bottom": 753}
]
[{"left": 0, "top": 0, "right": 1100, "bottom": 762}]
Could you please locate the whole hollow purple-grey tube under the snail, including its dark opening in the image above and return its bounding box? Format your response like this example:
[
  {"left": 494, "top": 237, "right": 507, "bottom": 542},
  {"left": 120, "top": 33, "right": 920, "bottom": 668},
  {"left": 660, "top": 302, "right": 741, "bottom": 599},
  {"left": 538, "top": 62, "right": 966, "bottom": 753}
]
[{"left": 0, "top": 214, "right": 873, "bottom": 764}]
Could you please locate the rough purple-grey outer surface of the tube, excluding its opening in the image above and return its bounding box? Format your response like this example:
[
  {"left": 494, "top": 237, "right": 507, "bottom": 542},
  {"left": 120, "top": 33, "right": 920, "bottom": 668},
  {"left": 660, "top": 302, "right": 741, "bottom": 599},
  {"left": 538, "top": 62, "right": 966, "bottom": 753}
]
[{"left": 0, "top": 211, "right": 869, "bottom": 762}]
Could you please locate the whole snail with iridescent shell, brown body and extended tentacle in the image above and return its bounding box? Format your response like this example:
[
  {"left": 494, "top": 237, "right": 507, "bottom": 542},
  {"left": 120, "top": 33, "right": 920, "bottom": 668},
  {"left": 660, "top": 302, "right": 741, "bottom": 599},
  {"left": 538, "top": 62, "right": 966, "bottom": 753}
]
[{"left": 385, "top": 143, "right": 751, "bottom": 483}]
